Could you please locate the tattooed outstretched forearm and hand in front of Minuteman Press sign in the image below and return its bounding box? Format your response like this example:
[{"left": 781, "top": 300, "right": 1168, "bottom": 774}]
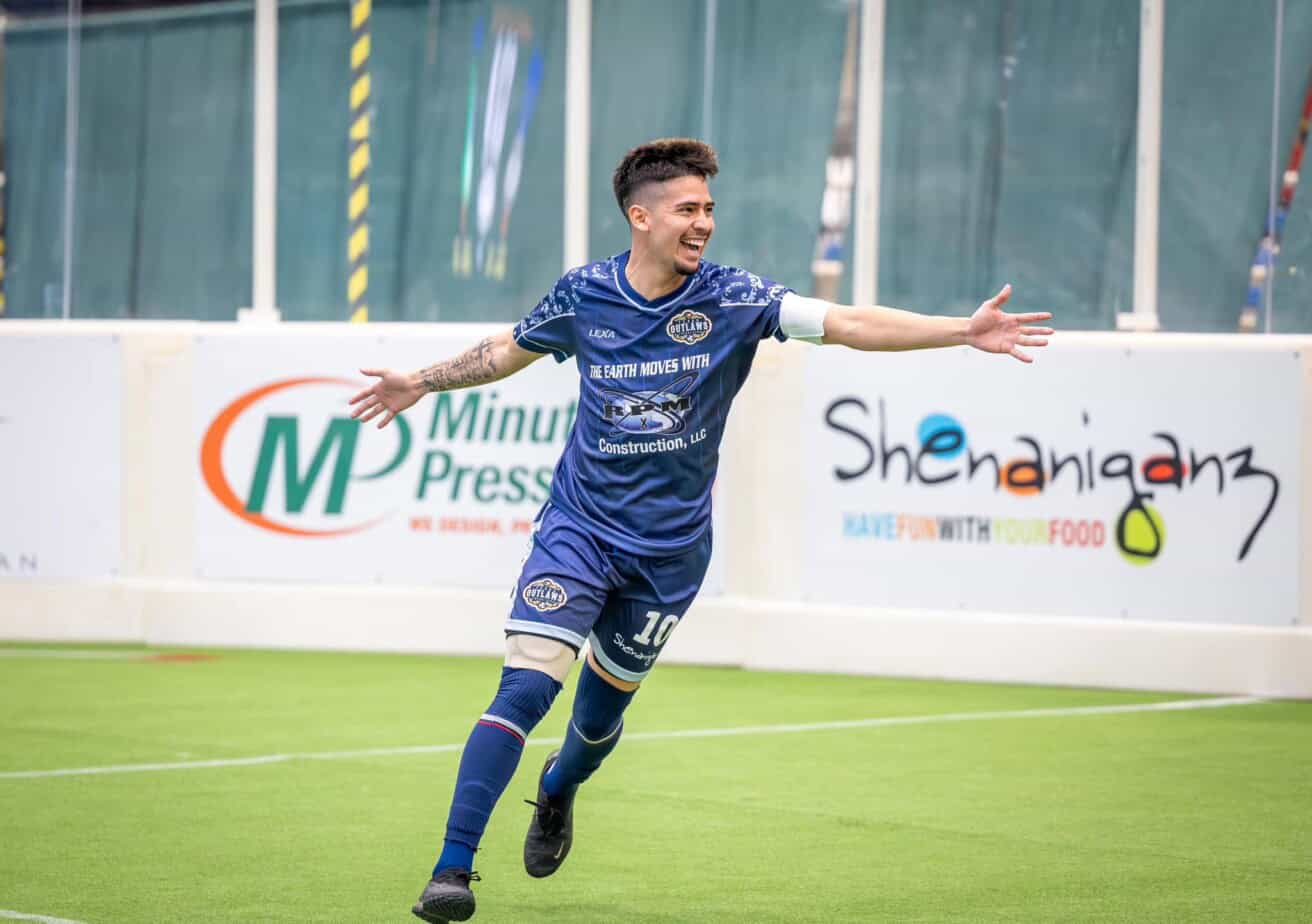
[{"left": 350, "top": 328, "right": 542, "bottom": 428}]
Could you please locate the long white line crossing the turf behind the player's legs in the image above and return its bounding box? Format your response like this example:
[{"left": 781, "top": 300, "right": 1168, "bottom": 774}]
[{"left": 0, "top": 696, "right": 1265, "bottom": 780}]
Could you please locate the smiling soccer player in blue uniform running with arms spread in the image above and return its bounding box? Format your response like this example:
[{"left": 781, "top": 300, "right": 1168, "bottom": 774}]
[{"left": 352, "top": 138, "right": 1052, "bottom": 921}]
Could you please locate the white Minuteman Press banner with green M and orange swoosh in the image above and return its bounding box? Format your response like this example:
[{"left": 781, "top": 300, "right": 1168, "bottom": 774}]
[{"left": 195, "top": 333, "right": 577, "bottom": 588}]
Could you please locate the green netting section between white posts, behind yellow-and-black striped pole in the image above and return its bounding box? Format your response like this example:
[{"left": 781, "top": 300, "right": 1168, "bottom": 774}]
[{"left": 278, "top": 0, "right": 565, "bottom": 322}]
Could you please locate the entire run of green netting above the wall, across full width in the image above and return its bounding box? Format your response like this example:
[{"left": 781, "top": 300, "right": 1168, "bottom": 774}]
[{"left": 4, "top": 0, "right": 1312, "bottom": 331}]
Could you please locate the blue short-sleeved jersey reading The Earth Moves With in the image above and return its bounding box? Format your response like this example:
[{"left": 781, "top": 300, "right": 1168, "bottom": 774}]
[{"left": 514, "top": 252, "right": 791, "bottom": 555}]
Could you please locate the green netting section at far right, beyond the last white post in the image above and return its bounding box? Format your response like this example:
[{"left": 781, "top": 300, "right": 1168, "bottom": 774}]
[{"left": 1157, "top": 0, "right": 1312, "bottom": 332}]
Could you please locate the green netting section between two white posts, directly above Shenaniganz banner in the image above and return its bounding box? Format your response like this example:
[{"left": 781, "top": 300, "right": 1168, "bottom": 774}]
[{"left": 879, "top": 0, "right": 1139, "bottom": 328}]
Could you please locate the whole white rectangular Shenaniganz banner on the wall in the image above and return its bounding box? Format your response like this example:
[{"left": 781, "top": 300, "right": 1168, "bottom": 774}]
[{"left": 802, "top": 344, "right": 1307, "bottom": 625}]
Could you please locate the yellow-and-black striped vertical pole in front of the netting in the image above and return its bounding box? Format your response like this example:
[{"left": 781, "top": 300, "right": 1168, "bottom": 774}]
[{"left": 346, "top": 0, "right": 371, "bottom": 323}]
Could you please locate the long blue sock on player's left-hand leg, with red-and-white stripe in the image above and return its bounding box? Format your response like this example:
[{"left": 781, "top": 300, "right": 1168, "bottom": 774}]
[{"left": 433, "top": 667, "right": 560, "bottom": 875}]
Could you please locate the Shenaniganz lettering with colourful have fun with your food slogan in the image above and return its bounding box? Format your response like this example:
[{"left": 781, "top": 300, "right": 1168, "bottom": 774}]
[{"left": 824, "top": 395, "right": 1282, "bottom": 566}]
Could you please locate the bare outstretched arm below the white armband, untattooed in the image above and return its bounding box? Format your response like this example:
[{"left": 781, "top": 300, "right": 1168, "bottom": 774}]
[{"left": 824, "top": 285, "right": 1054, "bottom": 362}]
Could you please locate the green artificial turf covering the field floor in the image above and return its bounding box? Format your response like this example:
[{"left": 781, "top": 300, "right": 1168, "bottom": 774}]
[{"left": 0, "top": 646, "right": 1312, "bottom": 924}]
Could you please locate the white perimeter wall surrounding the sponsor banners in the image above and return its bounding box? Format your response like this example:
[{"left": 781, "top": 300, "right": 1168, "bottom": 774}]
[{"left": 0, "top": 322, "right": 1312, "bottom": 697}]
